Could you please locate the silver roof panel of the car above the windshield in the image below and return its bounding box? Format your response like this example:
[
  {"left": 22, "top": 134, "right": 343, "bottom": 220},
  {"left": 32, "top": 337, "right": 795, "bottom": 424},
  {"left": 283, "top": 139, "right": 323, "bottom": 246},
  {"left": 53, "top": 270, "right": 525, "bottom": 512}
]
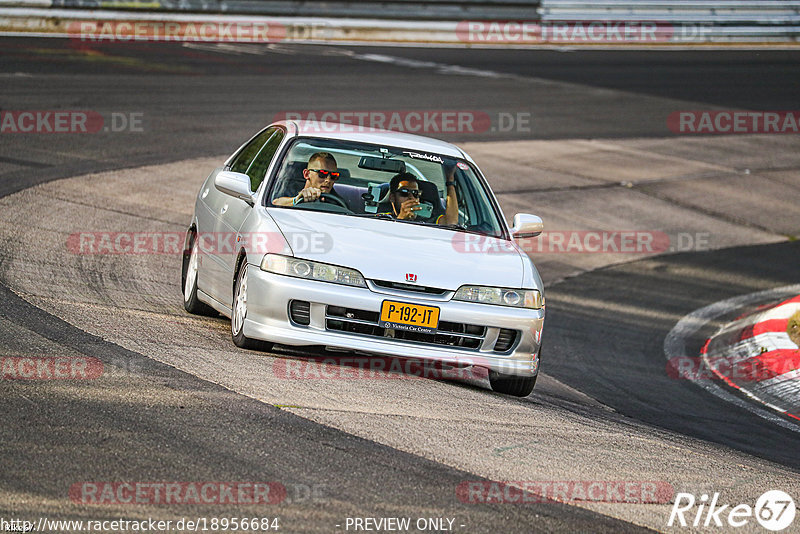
[{"left": 274, "top": 120, "right": 465, "bottom": 158}]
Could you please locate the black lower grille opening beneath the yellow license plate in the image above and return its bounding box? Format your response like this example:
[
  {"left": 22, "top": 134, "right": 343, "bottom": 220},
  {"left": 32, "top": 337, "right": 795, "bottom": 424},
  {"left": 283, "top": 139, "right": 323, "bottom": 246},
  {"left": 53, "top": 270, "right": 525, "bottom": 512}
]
[{"left": 325, "top": 306, "right": 486, "bottom": 350}]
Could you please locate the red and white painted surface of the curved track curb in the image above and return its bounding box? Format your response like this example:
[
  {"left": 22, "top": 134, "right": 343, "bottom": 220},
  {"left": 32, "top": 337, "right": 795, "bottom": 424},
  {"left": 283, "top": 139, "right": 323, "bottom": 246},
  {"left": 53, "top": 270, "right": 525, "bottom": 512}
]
[{"left": 700, "top": 296, "right": 800, "bottom": 420}]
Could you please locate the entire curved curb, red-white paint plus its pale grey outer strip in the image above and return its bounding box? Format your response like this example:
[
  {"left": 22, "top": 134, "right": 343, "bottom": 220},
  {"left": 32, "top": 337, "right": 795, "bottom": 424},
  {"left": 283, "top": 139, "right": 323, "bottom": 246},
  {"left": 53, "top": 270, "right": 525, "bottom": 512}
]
[{"left": 664, "top": 284, "right": 800, "bottom": 432}]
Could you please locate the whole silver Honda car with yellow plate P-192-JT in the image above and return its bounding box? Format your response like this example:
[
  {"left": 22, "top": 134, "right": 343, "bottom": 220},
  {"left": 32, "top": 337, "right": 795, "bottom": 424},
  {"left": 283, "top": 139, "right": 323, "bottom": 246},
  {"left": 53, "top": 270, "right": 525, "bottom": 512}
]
[{"left": 183, "top": 121, "right": 545, "bottom": 396}]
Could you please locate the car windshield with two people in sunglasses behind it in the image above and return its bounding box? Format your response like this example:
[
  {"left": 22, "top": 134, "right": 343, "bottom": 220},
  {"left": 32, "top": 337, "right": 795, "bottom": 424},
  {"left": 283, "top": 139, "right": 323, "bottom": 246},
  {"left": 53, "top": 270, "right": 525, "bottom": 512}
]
[{"left": 267, "top": 138, "right": 503, "bottom": 237}]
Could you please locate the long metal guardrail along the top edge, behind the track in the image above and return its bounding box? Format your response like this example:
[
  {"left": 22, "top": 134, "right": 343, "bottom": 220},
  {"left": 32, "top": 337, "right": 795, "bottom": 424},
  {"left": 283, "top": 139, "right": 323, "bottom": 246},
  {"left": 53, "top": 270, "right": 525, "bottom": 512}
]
[{"left": 0, "top": 0, "right": 800, "bottom": 42}]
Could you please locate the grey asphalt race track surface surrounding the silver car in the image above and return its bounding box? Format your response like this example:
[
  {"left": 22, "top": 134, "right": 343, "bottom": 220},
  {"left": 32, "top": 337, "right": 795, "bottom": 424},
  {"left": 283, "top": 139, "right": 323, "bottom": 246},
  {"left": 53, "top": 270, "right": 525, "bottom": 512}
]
[{"left": 0, "top": 38, "right": 800, "bottom": 533}]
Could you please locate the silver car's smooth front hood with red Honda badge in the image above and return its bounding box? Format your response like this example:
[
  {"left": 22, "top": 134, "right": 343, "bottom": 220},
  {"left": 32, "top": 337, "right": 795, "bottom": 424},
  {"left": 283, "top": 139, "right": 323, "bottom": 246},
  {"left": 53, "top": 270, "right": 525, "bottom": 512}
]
[{"left": 268, "top": 208, "right": 524, "bottom": 290}]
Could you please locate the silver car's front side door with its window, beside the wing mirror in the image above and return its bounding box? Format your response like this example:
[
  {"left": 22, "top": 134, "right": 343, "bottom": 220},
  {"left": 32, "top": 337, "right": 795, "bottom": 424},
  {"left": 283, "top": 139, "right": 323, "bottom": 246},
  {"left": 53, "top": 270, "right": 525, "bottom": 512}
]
[{"left": 215, "top": 126, "right": 285, "bottom": 306}]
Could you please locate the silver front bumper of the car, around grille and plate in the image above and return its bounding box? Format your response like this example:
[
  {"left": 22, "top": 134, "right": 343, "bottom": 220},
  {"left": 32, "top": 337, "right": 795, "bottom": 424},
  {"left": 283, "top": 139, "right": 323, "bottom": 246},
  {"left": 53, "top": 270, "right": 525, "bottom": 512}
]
[{"left": 244, "top": 265, "right": 544, "bottom": 376}]
